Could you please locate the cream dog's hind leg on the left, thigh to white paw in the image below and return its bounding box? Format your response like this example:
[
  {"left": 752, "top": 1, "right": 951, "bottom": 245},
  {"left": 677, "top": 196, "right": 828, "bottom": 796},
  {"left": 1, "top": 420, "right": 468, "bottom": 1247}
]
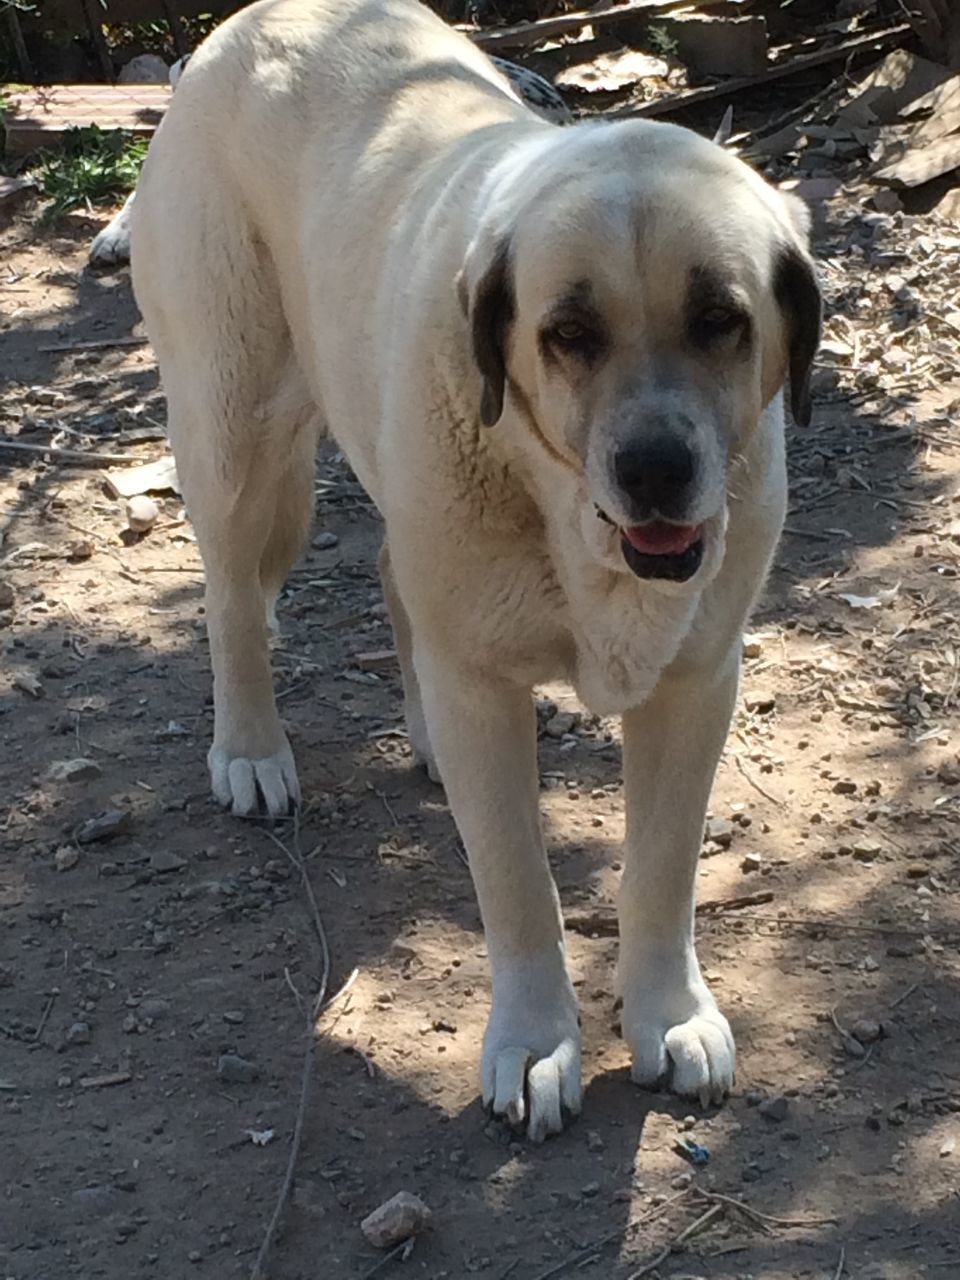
[{"left": 133, "top": 204, "right": 308, "bottom": 814}]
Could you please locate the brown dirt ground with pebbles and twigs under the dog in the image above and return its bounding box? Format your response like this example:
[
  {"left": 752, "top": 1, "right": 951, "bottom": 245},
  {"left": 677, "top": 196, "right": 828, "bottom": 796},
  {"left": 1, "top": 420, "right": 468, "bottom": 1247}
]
[{"left": 0, "top": 186, "right": 960, "bottom": 1280}]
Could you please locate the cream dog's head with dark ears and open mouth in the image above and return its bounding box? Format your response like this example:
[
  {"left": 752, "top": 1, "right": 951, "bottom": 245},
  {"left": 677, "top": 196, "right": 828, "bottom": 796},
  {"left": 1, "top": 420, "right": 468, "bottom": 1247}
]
[{"left": 460, "top": 122, "right": 820, "bottom": 584}]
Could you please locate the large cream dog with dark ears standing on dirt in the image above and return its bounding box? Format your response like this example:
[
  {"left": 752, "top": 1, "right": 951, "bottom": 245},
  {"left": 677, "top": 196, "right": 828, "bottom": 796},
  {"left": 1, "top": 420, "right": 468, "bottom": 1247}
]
[{"left": 133, "top": 0, "right": 819, "bottom": 1138}]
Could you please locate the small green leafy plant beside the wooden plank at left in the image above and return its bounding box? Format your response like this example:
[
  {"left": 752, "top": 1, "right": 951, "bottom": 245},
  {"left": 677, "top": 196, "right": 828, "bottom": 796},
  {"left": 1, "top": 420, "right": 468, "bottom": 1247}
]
[{"left": 37, "top": 124, "right": 147, "bottom": 219}]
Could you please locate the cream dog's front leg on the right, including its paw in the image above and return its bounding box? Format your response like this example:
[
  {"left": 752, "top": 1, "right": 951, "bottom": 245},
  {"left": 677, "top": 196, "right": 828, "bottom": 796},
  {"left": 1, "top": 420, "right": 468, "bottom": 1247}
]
[{"left": 618, "top": 655, "right": 740, "bottom": 1106}]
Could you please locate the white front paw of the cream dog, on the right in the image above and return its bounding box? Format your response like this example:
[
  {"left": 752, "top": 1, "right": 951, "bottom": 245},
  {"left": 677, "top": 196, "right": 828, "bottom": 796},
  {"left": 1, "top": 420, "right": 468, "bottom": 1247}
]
[{"left": 621, "top": 979, "right": 736, "bottom": 1107}]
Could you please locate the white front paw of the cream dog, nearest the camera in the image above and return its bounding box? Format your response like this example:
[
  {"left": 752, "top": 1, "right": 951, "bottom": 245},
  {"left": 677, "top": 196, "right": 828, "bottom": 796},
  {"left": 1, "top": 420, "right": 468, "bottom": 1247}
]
[{"left": 480, "top": 978, "right": 581, "bottom": 1142}]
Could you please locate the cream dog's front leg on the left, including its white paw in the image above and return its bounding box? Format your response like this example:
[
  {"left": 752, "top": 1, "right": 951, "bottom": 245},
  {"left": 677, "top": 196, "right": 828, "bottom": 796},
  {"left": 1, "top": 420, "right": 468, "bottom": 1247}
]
[{"left": 416, "top": 645, "right": 580, "bottom": 1140}]
